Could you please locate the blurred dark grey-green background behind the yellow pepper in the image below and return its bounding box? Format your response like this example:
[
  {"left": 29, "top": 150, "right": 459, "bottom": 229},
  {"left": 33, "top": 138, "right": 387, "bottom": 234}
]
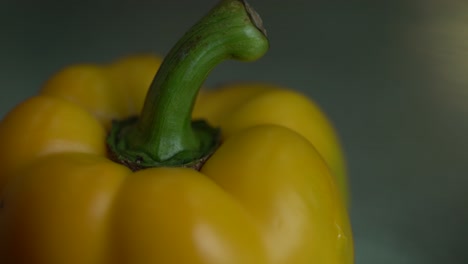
[{"left": 0, "top": 0, "right": 468, "bottom": 264}]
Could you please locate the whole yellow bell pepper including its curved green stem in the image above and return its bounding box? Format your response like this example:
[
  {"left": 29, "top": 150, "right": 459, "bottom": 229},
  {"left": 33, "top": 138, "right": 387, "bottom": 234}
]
[{"left": 0, "top": 0, "right": 353, "bottom": 264}]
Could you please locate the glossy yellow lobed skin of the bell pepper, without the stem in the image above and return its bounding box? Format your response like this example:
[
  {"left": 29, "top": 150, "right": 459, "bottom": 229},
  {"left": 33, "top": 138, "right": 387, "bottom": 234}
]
[{"left": 0, "top": 53, "right": 353, "bottom": 264}]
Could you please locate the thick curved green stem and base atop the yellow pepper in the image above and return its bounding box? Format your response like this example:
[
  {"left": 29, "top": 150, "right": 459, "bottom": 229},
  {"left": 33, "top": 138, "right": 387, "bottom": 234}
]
[{"left": 108, "top": 0, "right": 268, "bottom": 170}]
